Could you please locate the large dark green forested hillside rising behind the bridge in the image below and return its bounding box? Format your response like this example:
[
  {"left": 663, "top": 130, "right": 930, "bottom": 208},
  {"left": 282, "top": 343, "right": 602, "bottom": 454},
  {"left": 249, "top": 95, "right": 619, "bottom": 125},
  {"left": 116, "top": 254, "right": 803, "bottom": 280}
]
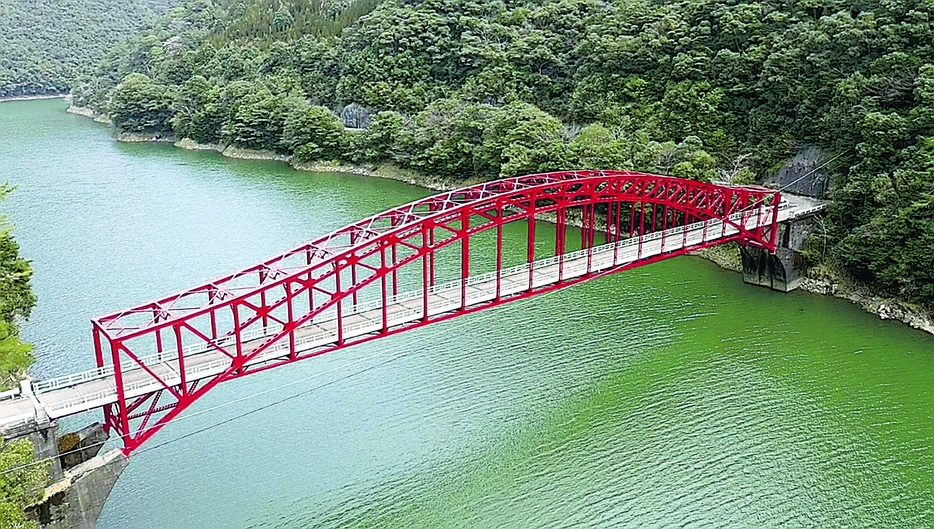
[{"left": 75, "top": 0, "right": 934, "bottom": 306}]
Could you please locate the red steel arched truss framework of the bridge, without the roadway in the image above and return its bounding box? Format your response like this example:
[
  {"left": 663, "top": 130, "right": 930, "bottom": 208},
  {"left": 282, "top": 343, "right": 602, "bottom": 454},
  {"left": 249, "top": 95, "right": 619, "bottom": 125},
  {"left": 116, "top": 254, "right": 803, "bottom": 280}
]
[{"left": 93, "top": 171, "right": 780, "bottom": 454}]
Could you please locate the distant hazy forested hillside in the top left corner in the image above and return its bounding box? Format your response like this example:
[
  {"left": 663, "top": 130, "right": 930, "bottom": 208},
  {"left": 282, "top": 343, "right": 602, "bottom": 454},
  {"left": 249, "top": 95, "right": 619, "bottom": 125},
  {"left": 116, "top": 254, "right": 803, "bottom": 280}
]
[{"left": 0, "top": 0, "right": 173, "bottom": 97}]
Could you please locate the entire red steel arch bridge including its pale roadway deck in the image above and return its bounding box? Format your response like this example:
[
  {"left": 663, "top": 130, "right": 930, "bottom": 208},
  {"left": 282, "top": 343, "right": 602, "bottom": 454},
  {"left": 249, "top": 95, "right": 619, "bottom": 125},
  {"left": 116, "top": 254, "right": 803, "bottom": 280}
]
[{"left": 0, "top": 171, "right": 794, "bottom": 454}]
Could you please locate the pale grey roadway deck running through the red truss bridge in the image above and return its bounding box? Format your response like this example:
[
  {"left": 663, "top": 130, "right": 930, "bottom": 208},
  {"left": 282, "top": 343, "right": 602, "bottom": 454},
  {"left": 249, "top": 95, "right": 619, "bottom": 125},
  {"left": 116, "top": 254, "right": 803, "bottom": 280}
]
[{"left": 0, "top": 200, "right": 822, "bottom": 428}]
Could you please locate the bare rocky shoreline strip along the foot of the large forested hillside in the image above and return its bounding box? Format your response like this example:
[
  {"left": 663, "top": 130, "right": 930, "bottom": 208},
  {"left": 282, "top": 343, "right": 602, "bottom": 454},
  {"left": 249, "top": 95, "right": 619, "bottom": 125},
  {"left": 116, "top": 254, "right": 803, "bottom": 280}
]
[{"left": 67, "top": 106, "right": 934, "bottom": 334}]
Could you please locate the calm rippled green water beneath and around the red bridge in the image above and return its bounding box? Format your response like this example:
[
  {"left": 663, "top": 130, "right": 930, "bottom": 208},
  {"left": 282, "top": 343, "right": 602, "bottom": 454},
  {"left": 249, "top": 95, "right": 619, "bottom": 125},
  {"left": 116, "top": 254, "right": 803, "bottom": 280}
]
[{"left": 0, "top": 101, "right": 934, "bottom": 529}]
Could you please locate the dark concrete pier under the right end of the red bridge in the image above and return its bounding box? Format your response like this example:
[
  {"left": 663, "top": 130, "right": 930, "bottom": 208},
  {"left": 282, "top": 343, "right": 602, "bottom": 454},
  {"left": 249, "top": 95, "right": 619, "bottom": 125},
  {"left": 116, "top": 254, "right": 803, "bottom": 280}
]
[{"left": 739, "top": 215, "right": 818, "bottom": 292}]
